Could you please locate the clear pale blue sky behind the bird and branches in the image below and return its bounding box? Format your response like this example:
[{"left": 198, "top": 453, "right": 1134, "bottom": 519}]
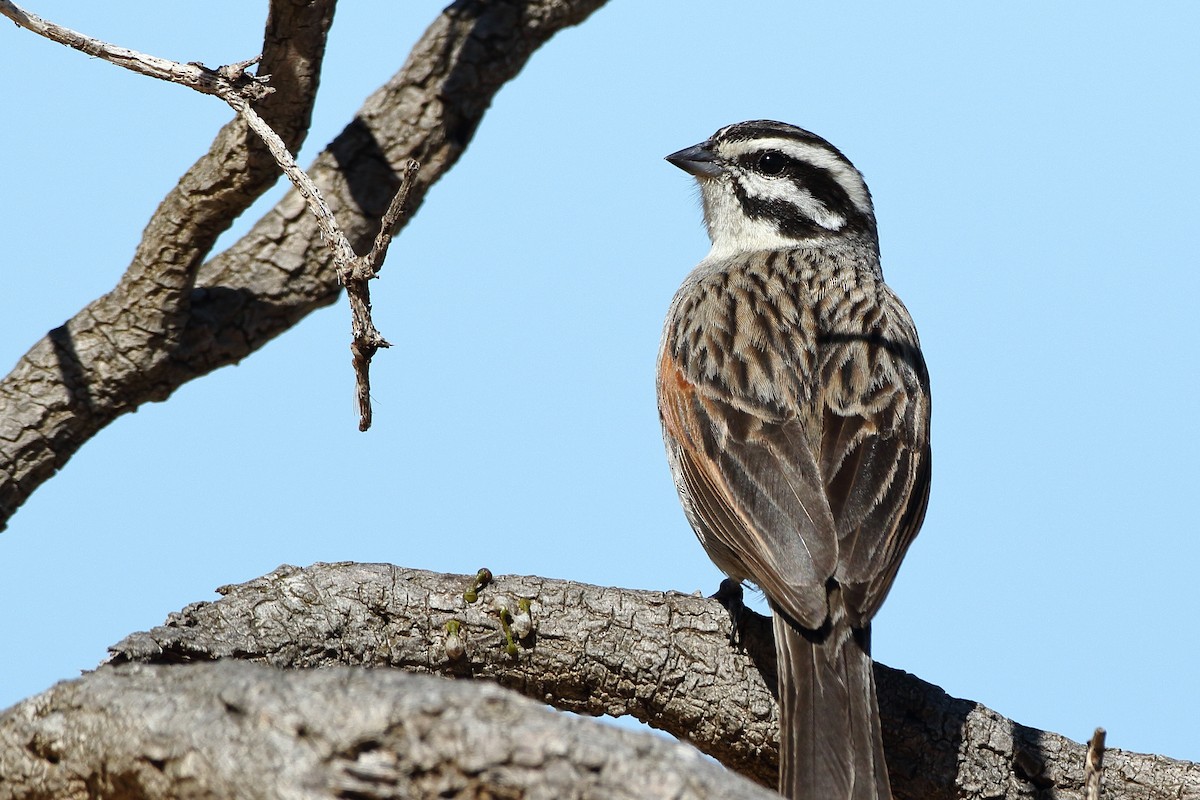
[{"left": 0, "top": 0, "right": 1200, "bottom": 760}]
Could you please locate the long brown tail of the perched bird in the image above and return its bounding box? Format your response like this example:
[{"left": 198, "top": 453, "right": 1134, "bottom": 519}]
[{"left": 774, "top": 612, "right": 892, "bottom": 800}]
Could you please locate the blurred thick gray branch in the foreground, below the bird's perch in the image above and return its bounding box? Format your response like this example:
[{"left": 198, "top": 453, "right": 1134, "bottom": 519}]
[{"left": 0, "top": 662, "right": 776, "bottom": 800}]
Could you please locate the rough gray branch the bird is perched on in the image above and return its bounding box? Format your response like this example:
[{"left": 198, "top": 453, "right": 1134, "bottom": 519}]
[{"left": 103, "top": 564, "right": 1200, "bottom": 800}]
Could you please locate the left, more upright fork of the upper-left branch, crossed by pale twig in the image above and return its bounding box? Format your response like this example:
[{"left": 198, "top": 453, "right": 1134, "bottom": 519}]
[{"left": 0, "top": 0, "right": 335, "bottom": 529}]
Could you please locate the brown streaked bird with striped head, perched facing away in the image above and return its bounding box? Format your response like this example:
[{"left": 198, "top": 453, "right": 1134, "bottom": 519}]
[{"left": 656, "top": 120, "right": 930, "bottom": 800}]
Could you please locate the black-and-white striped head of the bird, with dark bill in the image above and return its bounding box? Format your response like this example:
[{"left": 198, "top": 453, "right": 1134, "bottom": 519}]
[{"left": 667, "top": 120, "right": 877, "bottom": 257}]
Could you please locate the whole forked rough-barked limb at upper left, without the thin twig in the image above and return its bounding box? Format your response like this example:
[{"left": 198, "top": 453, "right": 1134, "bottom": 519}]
[{"left": 0, "top": 0, "right": 604, "bottom": 528}]
